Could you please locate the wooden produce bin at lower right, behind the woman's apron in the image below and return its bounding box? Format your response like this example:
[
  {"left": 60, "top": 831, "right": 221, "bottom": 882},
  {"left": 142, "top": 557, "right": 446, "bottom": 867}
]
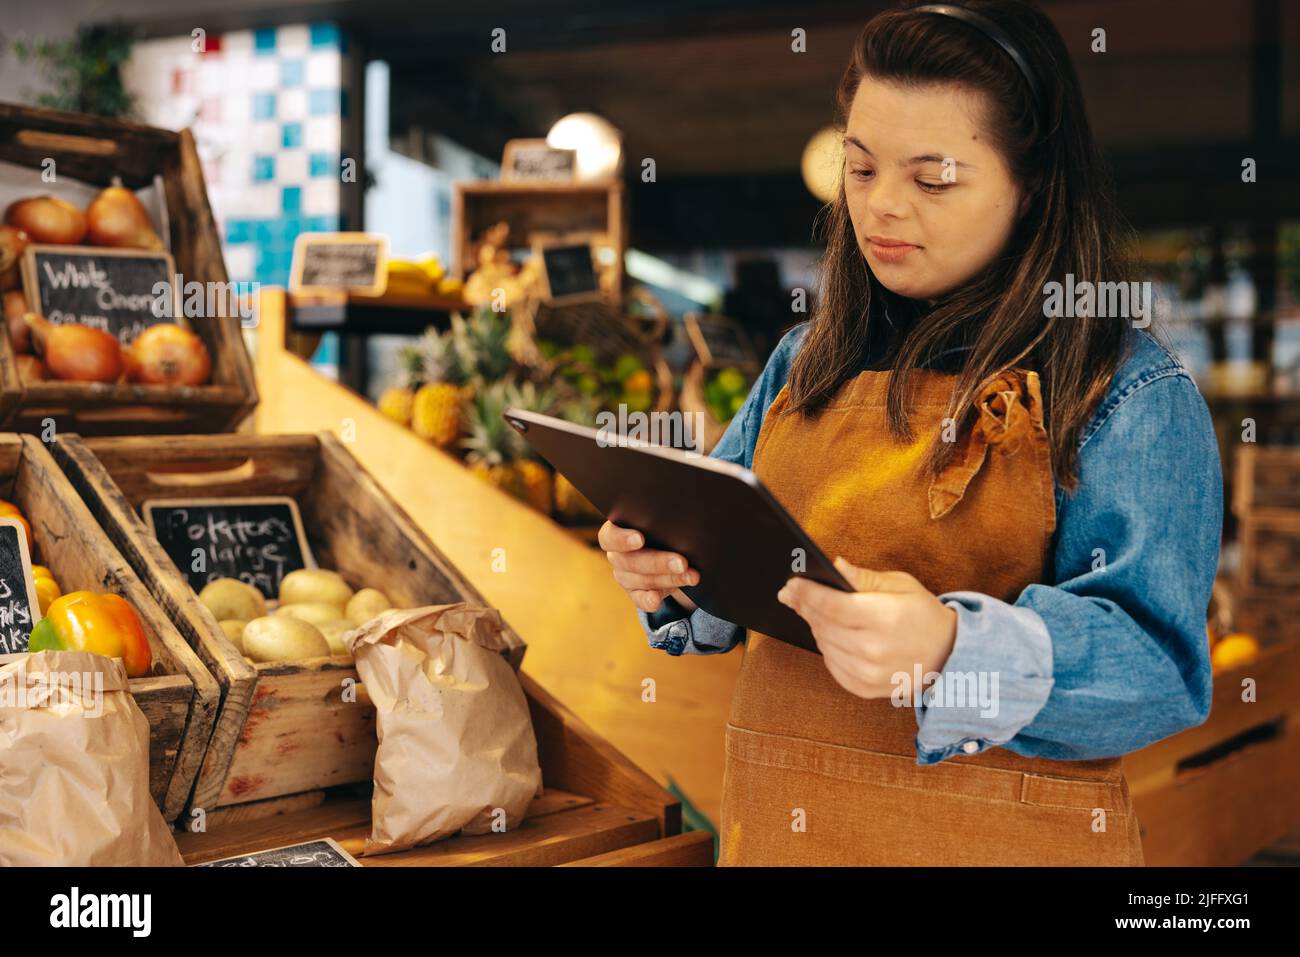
[{"left": 1125, "top": 641, "right": 1300, "bottom": 866}]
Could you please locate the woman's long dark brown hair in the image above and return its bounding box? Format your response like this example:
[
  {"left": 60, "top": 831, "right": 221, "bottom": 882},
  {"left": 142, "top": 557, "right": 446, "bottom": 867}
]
[{"left": 789, "top": 0, "right": 1132, "bottom": 490}]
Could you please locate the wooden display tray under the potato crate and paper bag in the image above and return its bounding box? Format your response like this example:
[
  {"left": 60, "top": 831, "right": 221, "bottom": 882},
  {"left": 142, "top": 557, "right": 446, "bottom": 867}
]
[{"left": 177, "top": 674, "right": 696, "bottom": 867}]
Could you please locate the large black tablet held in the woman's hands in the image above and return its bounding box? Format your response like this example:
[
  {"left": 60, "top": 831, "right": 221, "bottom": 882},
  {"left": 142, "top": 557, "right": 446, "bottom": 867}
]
[{"left": 506, "top": 408, "right": 853, "bottom": 651}]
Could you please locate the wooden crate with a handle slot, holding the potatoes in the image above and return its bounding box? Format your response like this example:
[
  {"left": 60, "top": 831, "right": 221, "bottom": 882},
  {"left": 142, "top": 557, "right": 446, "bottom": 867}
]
[{"left": 56, "top": 433, "right": 524, "bottom": 811}]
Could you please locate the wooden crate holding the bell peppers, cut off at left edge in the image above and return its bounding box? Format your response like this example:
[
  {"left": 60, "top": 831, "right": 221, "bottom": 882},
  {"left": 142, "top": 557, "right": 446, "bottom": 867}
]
[{"left": 0, "top": 434, "right": 220, "bottom": 820}]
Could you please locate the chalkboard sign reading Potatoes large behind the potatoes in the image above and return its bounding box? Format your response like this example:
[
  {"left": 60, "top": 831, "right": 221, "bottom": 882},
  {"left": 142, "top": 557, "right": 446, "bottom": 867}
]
[{"left": 140, "top": 497, "right": 316, "bottom": 598}]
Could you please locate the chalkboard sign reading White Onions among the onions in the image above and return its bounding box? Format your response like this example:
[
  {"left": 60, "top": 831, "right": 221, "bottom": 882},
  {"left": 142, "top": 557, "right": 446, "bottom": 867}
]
[{"left": 22, "top": 244, "right": 181, "bottom": 346}]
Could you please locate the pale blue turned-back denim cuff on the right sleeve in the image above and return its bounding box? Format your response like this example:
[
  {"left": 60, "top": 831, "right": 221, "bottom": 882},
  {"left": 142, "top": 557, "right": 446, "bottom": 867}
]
[{"left": 914, "top": 592, "right": 1054, "bottom": 765}]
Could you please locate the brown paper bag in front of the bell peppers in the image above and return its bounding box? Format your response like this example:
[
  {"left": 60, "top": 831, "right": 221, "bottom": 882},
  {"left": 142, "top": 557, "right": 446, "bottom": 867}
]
[{"left": 0, "top": 651, "right": 185, "bottom": 867}]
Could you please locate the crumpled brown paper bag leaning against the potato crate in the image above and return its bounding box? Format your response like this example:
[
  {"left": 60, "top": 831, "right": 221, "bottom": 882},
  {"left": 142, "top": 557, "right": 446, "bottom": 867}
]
[{"left": 343, "top": 602, "right": 542, "bottom": 854}]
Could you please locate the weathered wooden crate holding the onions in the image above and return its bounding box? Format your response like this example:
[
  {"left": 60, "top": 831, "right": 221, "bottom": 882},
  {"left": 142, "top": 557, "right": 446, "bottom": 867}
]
[{"left": 0, "top": 103, "right": 257, "bottom": 436}]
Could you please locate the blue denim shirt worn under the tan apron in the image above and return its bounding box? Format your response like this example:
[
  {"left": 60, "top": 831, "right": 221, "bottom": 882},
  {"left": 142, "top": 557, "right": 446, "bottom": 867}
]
[{"left": 637, "top": 324, "right": 1223, "bottom": 765}]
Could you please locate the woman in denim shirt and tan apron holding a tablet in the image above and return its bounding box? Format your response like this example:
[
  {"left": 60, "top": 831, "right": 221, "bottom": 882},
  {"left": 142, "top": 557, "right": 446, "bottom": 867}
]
[{"left": 601, "top": 0, "right": 1222, "bottom": 865}]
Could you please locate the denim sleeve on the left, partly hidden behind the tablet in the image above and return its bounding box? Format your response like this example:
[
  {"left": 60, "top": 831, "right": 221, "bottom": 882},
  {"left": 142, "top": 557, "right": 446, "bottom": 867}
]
[{"left": 637, "top": 324, "right": 807, "bottom": 655}]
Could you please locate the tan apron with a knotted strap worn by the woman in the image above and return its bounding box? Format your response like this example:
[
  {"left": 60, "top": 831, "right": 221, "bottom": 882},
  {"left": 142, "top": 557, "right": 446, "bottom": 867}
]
[{"left": 719, "top": 369, "right": 1143, "bottom": 865}]
